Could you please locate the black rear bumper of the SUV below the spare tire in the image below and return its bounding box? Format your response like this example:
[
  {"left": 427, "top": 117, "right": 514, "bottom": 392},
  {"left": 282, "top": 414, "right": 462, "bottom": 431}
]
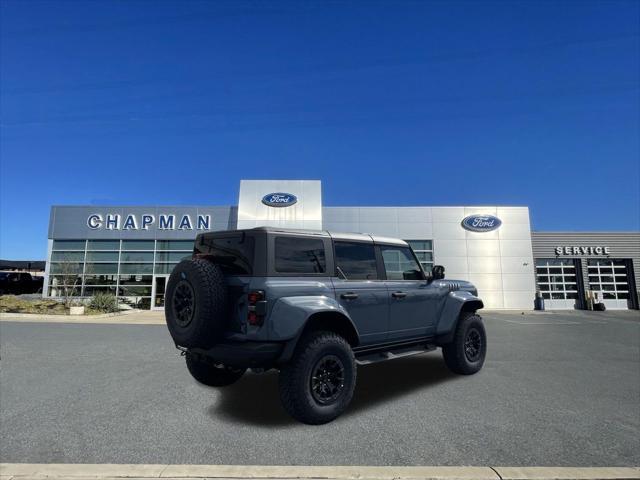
[{"left": 188, "top": 342, "right": 284, "bottom": 368}]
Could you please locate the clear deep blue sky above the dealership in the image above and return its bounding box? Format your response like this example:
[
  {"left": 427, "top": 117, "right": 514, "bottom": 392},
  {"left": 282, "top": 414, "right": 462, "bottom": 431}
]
[{"left": 0, "top": 0, "right": 640, "bottom": 259}]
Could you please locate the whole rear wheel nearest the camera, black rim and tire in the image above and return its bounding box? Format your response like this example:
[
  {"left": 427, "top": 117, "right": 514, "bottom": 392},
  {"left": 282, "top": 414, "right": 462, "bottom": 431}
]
[{"left": 279, "top": 332, "right": 356, "bottom": 425}]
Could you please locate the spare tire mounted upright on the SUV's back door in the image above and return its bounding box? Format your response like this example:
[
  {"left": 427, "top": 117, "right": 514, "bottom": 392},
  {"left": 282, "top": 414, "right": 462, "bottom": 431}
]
[{"left": 164, "top": 259, "right": 228, "bottom": 348}]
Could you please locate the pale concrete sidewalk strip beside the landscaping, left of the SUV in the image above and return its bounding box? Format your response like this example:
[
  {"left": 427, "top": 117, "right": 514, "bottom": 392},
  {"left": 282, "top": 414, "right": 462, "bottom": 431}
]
[{"left": 0, "top": 310, "right": 165, "bottom": 325}]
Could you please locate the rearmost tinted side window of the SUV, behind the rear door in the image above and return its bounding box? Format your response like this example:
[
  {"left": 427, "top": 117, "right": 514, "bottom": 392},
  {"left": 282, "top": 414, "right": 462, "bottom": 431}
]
[{"left": 275, "top": 237, "right": 326, "bottom": 273}]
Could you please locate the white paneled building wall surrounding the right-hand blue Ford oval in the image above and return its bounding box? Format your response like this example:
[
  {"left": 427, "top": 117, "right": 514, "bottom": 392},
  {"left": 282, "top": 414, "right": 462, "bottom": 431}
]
[{"left": 323, "top": 206, "right": 535, "bottom": 310}]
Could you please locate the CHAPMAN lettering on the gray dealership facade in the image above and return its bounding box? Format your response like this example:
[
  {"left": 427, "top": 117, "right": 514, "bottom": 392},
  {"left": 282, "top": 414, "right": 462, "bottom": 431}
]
[{"left": 87, "top": 213, "right": 211, "bottom": 230}]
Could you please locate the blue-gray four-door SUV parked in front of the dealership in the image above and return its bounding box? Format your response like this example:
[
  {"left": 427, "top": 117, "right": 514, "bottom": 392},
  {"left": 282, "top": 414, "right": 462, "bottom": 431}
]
[{"left": 165, "top": 228, "right": 487, "bottom": 424}]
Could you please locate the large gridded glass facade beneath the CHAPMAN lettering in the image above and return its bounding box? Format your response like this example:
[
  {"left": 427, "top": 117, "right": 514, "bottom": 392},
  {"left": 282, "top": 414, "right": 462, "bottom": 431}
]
[{"left": 49, "top": 240, "right": 193, "bottom": 308}]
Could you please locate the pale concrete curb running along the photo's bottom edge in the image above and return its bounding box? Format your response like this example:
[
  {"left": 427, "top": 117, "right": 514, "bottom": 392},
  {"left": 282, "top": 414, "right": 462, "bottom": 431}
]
[{"left": 0, "top": 463, "right": 640, "bottom": 480}]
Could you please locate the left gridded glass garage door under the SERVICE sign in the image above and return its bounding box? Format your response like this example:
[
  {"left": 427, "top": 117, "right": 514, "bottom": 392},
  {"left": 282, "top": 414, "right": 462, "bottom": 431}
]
[{"left": 536, "top": 258, "right": 578, "bottom": 300}]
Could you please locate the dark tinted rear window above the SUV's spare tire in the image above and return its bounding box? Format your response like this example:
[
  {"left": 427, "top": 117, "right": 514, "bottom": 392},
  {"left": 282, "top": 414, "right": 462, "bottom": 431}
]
[{"left": 195, "top": 233, "right": 255, "bottom": 275}]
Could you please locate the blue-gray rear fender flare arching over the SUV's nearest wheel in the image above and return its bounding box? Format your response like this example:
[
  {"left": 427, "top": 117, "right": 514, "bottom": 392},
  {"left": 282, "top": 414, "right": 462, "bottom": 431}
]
[{"left": 269, "top": 295, "right": 360, "bottom": 363}]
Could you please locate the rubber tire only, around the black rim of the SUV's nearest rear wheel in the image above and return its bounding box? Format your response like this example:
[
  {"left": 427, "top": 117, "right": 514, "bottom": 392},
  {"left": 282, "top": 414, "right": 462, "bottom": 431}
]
[{"left": 278, "top": 331, "right": 356, "bottom": 425}]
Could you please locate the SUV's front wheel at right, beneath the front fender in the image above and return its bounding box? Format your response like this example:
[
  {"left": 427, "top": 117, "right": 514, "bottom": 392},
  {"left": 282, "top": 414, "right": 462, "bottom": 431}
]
[{"left": 442, "top": 312, "right": 487, "bottom": 375}]
